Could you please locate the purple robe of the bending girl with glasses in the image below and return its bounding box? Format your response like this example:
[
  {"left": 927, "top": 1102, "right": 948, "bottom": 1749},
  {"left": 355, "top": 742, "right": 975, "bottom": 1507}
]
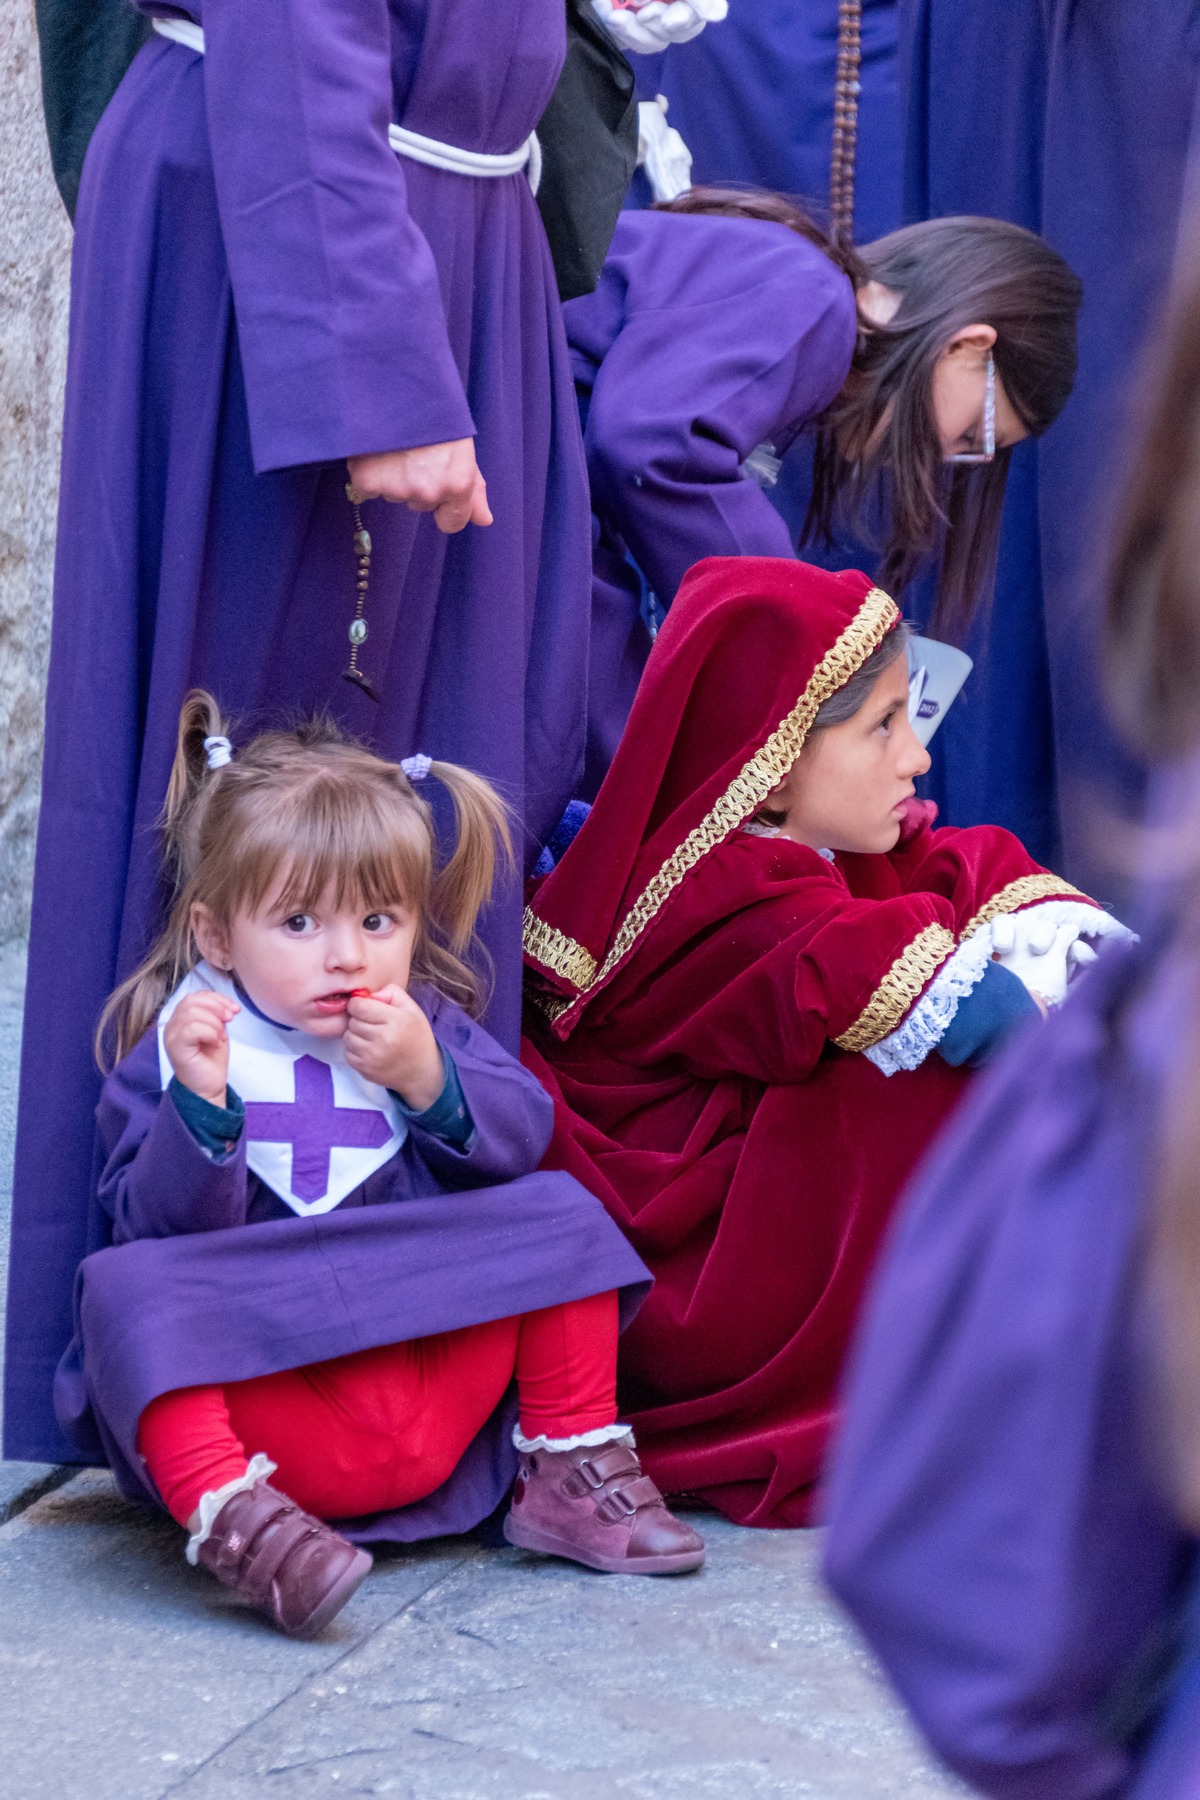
[{"left": 563, "top": 212, "right": 858, "bottom": 794}]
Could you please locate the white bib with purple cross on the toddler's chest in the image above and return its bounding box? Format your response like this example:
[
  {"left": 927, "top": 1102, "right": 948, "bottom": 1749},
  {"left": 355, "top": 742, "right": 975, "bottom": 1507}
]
[{"left": 158, "top": 963, "right": 408, "bottom": 1217}]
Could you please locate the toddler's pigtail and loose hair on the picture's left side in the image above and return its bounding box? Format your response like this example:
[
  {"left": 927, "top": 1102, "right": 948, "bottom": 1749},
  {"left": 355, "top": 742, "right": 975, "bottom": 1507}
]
[{"left": 94, "top": 688, "right": 228, "bottom": 1073}]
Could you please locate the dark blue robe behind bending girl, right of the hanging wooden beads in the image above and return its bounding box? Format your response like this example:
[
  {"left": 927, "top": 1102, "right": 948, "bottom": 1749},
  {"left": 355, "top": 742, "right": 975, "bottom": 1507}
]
[{"left": 900, "top": 0, "right": 1200, "bottom": 878}]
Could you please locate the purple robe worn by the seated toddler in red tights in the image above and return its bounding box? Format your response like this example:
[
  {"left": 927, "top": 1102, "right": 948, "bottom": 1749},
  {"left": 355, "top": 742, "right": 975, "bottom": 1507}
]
[{"left": 54, "top": 994, "right": 649, "bottom": 1541}]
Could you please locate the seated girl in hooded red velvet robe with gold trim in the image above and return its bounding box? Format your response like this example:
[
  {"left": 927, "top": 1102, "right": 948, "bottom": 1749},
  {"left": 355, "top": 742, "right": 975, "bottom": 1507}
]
[{"left": 525, "top": 558, "right": 1123, "bottom": 1526}]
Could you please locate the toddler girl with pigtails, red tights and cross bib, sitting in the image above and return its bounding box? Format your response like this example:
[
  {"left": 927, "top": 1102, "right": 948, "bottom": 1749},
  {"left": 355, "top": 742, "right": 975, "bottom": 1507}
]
[{"left": 56, "top": 693, "right": 703, "bottom": 1636}]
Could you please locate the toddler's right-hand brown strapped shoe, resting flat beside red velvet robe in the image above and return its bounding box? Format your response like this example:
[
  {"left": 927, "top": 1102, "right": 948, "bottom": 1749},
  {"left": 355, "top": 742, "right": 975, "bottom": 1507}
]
[{"left": 504, "top": 1442, "right": 703, "bottom": 1575}]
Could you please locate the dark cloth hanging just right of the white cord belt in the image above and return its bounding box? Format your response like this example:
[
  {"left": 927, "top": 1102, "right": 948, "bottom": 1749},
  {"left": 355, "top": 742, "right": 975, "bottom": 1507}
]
[{"left": 538, "top": 0, "right": 637, "bottom": 301}]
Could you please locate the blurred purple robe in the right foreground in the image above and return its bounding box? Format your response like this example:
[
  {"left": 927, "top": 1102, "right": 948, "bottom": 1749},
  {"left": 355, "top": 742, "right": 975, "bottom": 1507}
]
[{"left": 826, "top": 945, "right": 1196, "bottom": 1800}]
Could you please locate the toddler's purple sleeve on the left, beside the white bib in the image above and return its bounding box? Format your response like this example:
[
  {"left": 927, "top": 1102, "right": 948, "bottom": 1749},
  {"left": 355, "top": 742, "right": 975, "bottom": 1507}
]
[{"left": 97, "top": 1031, "right": 248, "bottom": 1244}]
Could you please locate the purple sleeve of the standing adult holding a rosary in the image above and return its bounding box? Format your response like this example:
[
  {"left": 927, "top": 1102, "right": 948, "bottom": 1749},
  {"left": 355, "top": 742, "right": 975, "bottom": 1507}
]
[{"left": 203, "top": 0, "right": 475, "bottom": 473}]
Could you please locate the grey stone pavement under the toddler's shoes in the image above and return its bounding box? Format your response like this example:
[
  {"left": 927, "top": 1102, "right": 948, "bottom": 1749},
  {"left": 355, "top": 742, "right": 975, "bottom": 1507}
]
[{"left": 0, "top": 950, "right": 963, "bottom": 1800}]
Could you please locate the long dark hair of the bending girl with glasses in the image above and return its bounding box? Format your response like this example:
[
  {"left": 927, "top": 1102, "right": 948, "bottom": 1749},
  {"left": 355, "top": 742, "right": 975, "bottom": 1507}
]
[{"left": 660, "top": 187, "right": 1083, "bottom": 637}]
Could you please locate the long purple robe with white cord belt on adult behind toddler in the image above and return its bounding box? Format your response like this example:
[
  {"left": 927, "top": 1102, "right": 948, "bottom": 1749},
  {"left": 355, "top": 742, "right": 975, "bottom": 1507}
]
[{"left": 5, "top": 0, "right": 590, "bottom": 1462}]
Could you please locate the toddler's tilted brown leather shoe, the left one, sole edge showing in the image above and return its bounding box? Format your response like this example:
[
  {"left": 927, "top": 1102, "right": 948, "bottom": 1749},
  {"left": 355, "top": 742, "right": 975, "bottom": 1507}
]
[{"left": 196, "top": 1481, "right": 371, "bottom": 1638}]
